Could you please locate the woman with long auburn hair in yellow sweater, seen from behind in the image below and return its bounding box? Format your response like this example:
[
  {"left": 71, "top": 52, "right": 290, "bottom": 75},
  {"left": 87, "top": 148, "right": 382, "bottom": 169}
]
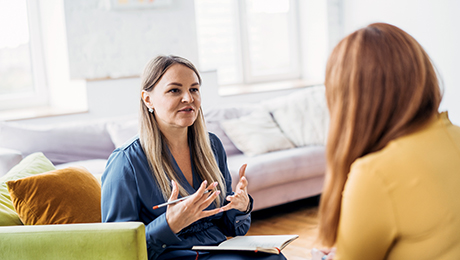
[{"left": 312, "top": 23, "right": 460, "bottom": 260}]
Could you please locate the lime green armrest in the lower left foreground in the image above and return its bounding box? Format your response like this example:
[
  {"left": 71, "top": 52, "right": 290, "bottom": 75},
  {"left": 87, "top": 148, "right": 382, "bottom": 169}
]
[{"left": 0, "top": 222, "right": 147, "bottom": 260}]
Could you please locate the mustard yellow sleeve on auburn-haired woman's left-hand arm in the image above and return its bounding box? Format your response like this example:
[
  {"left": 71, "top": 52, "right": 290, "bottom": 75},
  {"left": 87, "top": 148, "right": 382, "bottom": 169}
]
[{"left": 334, "top": 159, "right": 397, "bottom": 260}]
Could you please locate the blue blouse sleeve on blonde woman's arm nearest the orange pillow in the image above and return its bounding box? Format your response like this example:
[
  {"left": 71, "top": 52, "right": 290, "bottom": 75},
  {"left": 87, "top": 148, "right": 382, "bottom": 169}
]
[{"left": 101, "top": 150, "right": 181, "bottom": 259}]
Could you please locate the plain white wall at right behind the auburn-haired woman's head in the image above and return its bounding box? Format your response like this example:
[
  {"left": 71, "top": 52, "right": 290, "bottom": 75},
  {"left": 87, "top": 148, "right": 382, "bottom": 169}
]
[{"left": 343, "top": 0, "right": 460, "bottom": 124}]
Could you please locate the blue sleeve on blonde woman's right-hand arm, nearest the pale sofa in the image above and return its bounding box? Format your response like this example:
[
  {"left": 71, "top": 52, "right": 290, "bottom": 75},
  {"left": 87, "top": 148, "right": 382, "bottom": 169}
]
[{"left": 210, "top": 133, "right": 253, "bottom": 236}]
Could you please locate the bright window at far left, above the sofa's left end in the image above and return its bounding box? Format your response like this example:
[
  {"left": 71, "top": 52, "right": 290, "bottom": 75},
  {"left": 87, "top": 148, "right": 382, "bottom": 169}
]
[{"left": 0, "top": 0, "right": 47, "bottom": 110}]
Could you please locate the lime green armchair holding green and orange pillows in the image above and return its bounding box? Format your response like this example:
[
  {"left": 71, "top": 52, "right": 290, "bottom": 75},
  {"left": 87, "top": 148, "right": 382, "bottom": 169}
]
[{"left": 0, "top": 153, "right": 148, "bottom": 260}]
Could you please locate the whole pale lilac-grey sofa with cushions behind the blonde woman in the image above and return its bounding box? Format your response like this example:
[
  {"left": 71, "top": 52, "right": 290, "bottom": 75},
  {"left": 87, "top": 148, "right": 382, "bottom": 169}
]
[{"left": 0, "top": 87, "right": 328, "bottom": 210}]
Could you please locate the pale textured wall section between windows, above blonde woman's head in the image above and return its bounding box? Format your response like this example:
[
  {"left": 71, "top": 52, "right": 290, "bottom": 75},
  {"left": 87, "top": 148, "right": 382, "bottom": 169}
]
[{"left": 62, "top": 0, "right": 198, "bottom": 79}]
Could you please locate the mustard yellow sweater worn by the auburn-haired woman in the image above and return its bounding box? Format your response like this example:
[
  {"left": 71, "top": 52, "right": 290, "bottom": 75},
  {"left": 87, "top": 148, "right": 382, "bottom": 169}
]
[{"left": 334, "top": 112, "right": 460, "bottom": 260}]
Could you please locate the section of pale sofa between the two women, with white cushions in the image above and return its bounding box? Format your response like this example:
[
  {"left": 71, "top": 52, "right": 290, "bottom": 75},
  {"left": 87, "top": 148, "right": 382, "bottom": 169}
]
[{"left": 205, "top": 86, "right": 329, "bottom": 210}]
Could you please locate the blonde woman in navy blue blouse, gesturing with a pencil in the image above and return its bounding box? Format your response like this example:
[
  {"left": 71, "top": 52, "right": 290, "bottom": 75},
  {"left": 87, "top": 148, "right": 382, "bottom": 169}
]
[{"left": 102, "top": 56, "right": 285, "bottom": 260}]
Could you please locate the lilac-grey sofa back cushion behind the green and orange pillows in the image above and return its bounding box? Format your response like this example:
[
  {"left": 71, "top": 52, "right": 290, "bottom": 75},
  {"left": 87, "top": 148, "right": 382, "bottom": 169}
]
[{"left": 0, "top": 122, "right": 115, "bottom": 164}]
